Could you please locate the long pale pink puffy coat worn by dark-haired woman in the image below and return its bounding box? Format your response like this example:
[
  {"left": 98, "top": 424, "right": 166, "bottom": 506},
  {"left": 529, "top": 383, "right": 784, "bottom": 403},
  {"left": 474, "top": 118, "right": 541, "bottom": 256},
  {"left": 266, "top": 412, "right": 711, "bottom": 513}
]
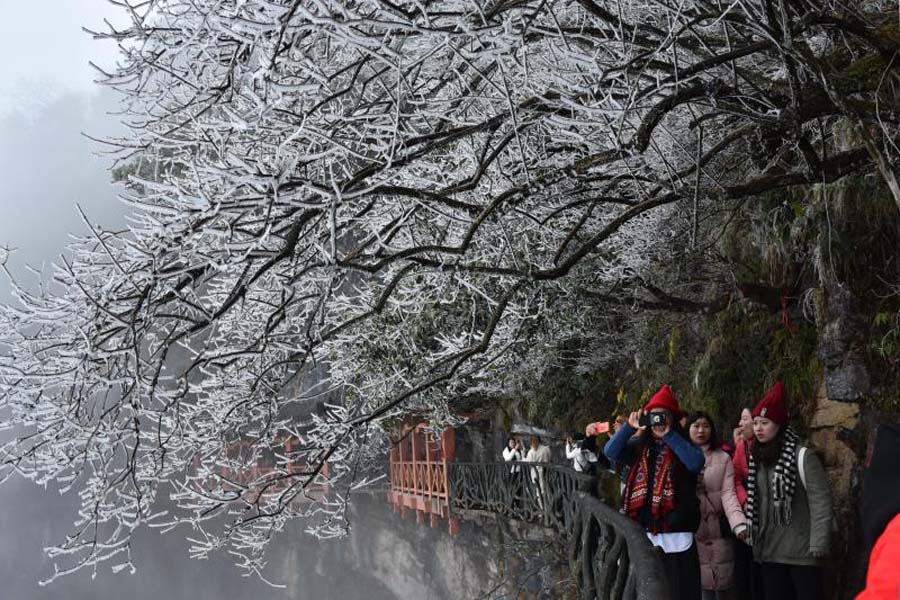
[{"left": 695, "top": 448, "right": 747, "bottom": 590}]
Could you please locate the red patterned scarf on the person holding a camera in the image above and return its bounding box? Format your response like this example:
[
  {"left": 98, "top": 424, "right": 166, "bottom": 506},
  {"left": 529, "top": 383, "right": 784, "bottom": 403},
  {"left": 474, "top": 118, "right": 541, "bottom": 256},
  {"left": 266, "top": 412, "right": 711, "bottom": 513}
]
[{"left": 623, "top": 441, "right": 675, "bottom": 534}]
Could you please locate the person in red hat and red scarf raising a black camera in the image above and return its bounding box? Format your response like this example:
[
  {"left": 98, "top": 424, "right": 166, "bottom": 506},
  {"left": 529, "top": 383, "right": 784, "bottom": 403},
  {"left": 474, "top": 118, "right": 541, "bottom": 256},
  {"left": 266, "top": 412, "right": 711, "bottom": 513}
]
[{"left": 604, "top": 385, "right": 705, "bottom": 600}]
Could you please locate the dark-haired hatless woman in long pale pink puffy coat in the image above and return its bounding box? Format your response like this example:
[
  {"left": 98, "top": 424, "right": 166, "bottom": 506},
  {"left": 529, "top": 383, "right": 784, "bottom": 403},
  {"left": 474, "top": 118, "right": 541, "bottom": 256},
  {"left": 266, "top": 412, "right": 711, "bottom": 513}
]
[{"left": 688, "top": 412, "right": 748, "bottom": 600}]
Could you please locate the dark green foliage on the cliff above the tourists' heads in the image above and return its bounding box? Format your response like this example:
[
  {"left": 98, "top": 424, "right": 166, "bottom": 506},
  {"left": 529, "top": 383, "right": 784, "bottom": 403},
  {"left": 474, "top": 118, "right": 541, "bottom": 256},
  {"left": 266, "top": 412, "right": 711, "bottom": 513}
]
[{"left": 523, "top": 171, "right": 900, "bottom": 429}]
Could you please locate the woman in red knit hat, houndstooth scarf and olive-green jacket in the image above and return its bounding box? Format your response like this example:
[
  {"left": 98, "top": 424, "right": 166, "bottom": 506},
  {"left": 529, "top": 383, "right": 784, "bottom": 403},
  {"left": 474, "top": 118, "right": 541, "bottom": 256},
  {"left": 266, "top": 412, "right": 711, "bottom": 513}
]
[{"left": 745, "top": 382, "right": 832, "bottom": 600}]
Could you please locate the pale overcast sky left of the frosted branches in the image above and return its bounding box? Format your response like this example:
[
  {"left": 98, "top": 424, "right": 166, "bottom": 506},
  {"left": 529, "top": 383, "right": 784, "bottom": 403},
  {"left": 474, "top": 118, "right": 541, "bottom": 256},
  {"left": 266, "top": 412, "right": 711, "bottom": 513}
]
[{"left": 0, "top": 0, "right": 128, "bottom": 301}]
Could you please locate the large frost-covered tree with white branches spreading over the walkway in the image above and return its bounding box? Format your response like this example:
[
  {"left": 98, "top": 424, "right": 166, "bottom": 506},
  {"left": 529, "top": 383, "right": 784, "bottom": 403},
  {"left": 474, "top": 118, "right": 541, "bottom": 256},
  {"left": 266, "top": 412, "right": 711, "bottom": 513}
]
[{"left": 0, "top": 0, "right": 900, "bottom": 573}]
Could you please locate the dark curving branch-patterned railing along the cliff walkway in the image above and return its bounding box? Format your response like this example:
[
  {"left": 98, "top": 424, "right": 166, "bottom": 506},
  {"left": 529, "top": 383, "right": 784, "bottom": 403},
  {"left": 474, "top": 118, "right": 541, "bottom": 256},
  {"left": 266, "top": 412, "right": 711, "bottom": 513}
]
[{"left": 447, "top": 463, "right": 670, "bottom": 600}]
